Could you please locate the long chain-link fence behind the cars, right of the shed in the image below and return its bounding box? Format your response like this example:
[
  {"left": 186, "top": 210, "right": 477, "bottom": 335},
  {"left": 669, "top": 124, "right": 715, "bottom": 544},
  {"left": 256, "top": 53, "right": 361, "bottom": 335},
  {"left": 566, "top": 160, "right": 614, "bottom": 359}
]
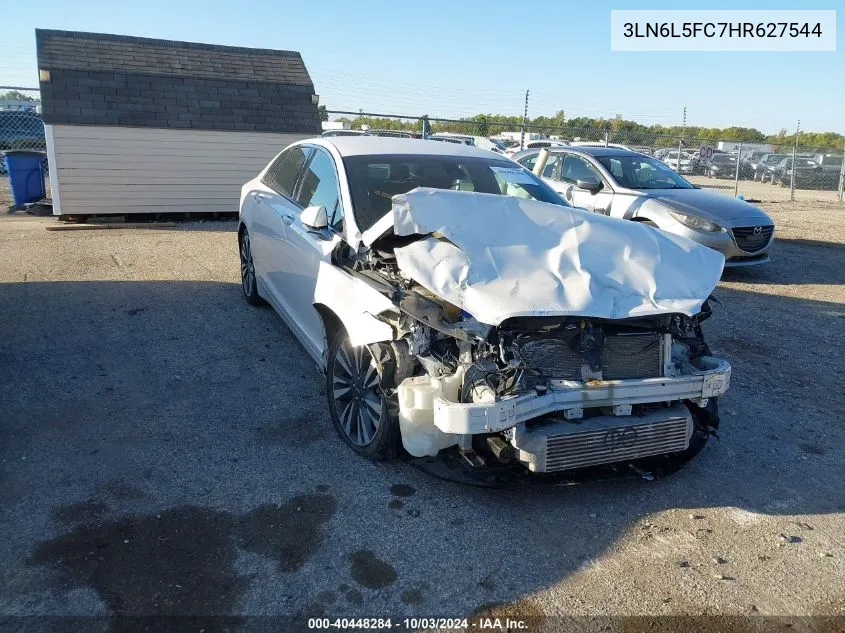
[{"left": 326, "top": 111, "right": 845, "bottom": 202}]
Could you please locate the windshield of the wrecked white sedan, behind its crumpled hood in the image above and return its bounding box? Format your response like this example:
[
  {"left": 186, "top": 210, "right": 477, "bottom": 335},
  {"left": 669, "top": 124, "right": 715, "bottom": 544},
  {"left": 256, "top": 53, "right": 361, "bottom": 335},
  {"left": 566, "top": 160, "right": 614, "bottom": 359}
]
[{"left": 343, "top": 155, "right": 568, "bottom": 231}]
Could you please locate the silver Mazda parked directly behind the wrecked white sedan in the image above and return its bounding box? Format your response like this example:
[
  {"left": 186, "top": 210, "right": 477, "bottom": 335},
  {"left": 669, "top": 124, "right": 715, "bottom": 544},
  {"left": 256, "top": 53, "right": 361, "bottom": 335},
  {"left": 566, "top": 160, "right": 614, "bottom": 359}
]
[{"left": 513, "top": 147, "right": 775, "bottom": 267}]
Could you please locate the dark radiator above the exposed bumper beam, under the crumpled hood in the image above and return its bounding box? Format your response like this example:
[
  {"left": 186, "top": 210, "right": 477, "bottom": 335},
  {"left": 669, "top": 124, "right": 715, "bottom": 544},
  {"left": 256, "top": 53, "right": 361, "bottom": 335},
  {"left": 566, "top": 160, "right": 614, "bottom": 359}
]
[{"left": 517, "top": 332, "right": 663, "bottom": 380}]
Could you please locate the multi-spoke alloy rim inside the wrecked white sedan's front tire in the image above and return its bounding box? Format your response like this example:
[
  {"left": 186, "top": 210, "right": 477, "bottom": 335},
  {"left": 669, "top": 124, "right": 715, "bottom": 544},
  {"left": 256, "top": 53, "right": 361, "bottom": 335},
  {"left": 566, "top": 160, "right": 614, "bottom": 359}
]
[{"left": 331, "top": 342, "right": 382, "bottom": 446}]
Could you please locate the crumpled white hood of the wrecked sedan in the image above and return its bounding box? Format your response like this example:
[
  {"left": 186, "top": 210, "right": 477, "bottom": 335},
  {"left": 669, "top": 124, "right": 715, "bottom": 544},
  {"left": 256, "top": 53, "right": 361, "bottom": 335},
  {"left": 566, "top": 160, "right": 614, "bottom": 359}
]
[{"left": 364, "top": 188, "right": 725, "bottom": 325}]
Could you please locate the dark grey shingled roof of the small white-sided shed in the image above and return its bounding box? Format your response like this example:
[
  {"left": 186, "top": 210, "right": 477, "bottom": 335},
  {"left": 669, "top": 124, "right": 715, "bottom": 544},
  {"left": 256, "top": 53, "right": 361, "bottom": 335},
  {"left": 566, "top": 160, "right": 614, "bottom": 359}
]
[{"left": 35, "top": 29, "right": 320, "bottom": 133}]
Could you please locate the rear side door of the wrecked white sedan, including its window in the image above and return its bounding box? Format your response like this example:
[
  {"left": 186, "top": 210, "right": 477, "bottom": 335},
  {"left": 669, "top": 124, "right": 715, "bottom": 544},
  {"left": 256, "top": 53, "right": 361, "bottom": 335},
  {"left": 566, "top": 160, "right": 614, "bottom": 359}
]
[{"left": 252, "top": 145, "right": 312, "bottom": 317}]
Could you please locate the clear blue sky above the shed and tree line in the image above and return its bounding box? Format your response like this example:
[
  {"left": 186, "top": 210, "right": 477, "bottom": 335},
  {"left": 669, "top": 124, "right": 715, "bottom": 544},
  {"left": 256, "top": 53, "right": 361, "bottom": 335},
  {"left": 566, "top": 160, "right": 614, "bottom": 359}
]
[{"left": 0, "top": 0, "right": 845, "bottom": 133}]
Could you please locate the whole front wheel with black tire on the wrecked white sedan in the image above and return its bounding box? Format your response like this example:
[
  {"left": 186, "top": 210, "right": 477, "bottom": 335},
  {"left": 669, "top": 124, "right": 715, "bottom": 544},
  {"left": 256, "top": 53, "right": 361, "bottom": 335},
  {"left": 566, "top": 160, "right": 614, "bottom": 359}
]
[{"left": 326, "top": 332, "right": 401, "bottom": 461}]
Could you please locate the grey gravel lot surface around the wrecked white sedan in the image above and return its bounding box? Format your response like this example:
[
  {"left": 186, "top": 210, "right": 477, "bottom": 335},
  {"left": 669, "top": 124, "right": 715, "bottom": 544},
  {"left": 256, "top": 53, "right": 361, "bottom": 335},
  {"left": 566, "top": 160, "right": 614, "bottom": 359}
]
[{"left": 0, "top": 205, "right": 845, "bottom": 631}]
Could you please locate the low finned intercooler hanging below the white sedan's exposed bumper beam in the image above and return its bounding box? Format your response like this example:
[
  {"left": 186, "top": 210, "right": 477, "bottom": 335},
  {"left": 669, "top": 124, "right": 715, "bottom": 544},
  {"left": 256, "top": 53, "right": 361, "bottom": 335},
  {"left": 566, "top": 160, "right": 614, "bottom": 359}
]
[{"left": 511, "top": 405, "right": 693, "bottom": 472}]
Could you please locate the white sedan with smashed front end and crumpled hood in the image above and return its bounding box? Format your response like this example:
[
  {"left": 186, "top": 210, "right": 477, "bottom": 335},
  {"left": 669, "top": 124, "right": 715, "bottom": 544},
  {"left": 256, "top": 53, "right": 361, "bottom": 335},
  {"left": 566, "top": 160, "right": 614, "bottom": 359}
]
[{"left": 238, "top": 137, "right": 731, "bottom": 473}]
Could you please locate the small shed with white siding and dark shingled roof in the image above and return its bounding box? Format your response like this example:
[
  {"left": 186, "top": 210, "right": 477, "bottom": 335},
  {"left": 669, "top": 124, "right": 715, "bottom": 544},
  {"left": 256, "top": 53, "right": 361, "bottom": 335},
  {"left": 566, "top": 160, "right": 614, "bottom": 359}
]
[{"left": 35, "top": 30, "right": 320, "bottom": 215}]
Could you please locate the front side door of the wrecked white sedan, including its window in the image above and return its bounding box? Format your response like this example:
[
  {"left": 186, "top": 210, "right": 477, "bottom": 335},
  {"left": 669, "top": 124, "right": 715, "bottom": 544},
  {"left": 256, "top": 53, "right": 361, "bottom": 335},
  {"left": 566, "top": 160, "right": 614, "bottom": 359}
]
[{"left": 276, "top": 147, "right": 344, "bottom": 353}]
